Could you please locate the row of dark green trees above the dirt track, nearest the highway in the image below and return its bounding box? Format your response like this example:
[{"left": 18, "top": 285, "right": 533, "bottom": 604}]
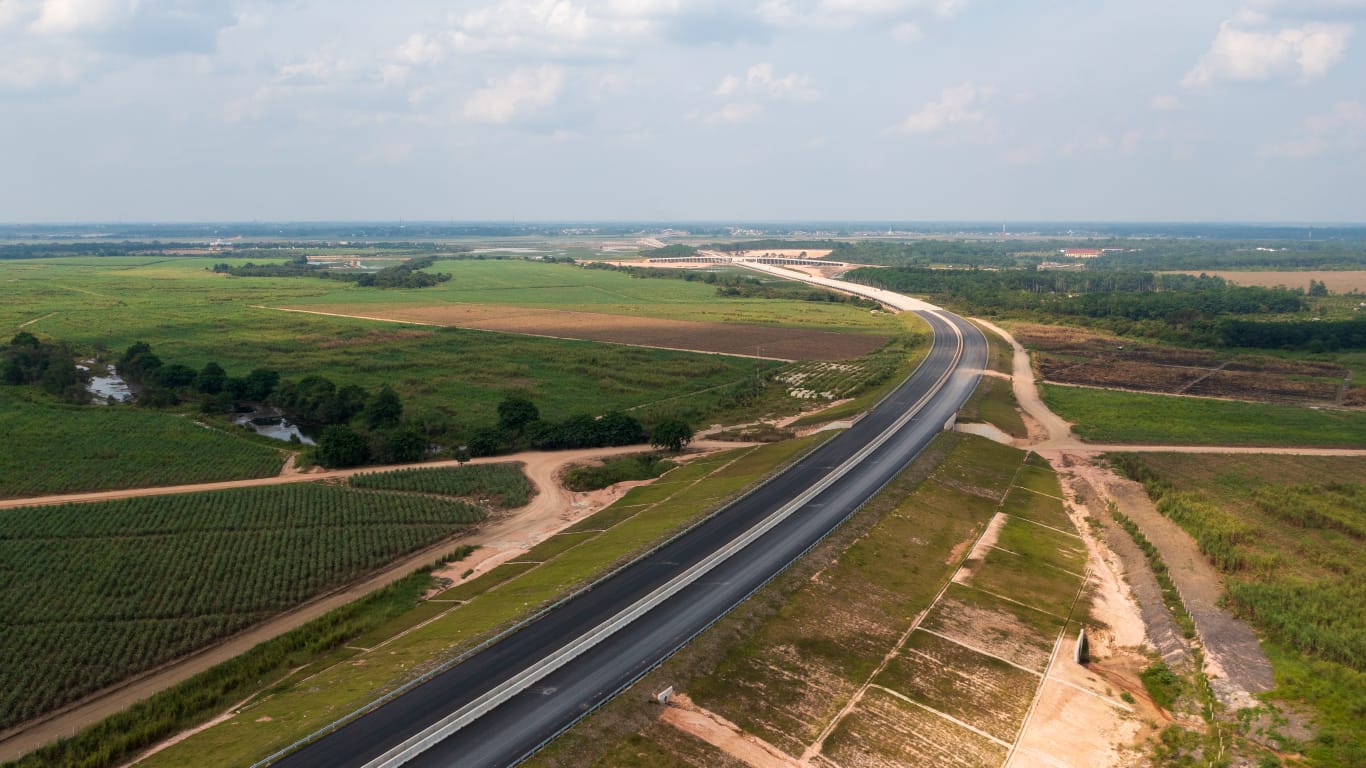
[{"left": 467, "top": 395, "right": 693, "bottom": 456}]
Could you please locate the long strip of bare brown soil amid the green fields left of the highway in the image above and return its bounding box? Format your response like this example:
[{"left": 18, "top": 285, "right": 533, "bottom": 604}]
[{"left": 277, "top": 303, "right": 889, "bottom": 361}]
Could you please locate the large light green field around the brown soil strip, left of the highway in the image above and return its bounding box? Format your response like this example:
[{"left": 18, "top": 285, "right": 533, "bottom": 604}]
[{"left": 0, "top": 257, "right": 902, "bottom": 430}]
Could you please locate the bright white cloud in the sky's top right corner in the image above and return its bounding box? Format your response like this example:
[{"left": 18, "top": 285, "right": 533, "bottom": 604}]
[{"left": 1182, "top": 8, "right": 1352, "bottom": 87}]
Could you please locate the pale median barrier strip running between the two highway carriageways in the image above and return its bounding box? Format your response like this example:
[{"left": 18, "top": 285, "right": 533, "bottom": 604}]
[{"left": 363, "top": 307, "right": 963, "bottom": 768}]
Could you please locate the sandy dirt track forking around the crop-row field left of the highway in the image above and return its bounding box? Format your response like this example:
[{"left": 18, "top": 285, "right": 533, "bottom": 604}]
[{"left": 0, "top": 440, "right": 747, "bottom": 761}]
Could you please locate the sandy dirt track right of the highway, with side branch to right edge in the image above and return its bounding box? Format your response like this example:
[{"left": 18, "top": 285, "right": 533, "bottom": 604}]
[{"left": 982, "top": 323, "right": 1278, "bottom": 709}]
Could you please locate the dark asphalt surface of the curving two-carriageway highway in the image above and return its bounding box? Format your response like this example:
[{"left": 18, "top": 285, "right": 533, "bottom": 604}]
[{"left": 276, "top": 307, "right": 986, "bottom": 768}]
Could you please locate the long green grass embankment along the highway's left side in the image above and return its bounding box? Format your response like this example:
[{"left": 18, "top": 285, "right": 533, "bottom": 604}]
[{"left": 64, "top": 435, "right": 826, "bottom": 768}]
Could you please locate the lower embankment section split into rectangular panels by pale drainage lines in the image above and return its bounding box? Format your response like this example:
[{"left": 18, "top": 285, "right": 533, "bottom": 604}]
[{"left": 854, "top": 456, "right": 1086, "bottom": 765}]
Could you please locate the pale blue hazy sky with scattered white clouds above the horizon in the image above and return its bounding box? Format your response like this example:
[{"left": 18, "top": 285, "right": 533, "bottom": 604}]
[{"left": 0, "top": 0, "right": 1366, "bottom": 223}]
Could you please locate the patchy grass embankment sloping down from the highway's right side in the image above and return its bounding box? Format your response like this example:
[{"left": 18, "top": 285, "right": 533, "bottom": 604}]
[{"left": 530, "top": 433, "right": 1085, "bottom": 768}]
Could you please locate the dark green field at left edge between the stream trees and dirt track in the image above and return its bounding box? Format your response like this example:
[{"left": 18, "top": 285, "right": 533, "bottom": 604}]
[{"left": 0, "top": 387, "right": 284, "bottom": 499}]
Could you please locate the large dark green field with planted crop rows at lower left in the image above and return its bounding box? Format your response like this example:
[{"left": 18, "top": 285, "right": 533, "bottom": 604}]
[{"left": 0, "top": 484, "right": 485, "bottom": 728}]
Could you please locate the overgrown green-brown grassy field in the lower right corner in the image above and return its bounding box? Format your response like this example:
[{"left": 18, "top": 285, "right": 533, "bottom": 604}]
[{"left": 1120, "top": 454, "right": 1366, "bottom": 768}]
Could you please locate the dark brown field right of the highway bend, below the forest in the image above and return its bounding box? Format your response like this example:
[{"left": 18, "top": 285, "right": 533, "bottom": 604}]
[{"left": 1012, "top": 325, "right": 1366, "bottom": 406}]
